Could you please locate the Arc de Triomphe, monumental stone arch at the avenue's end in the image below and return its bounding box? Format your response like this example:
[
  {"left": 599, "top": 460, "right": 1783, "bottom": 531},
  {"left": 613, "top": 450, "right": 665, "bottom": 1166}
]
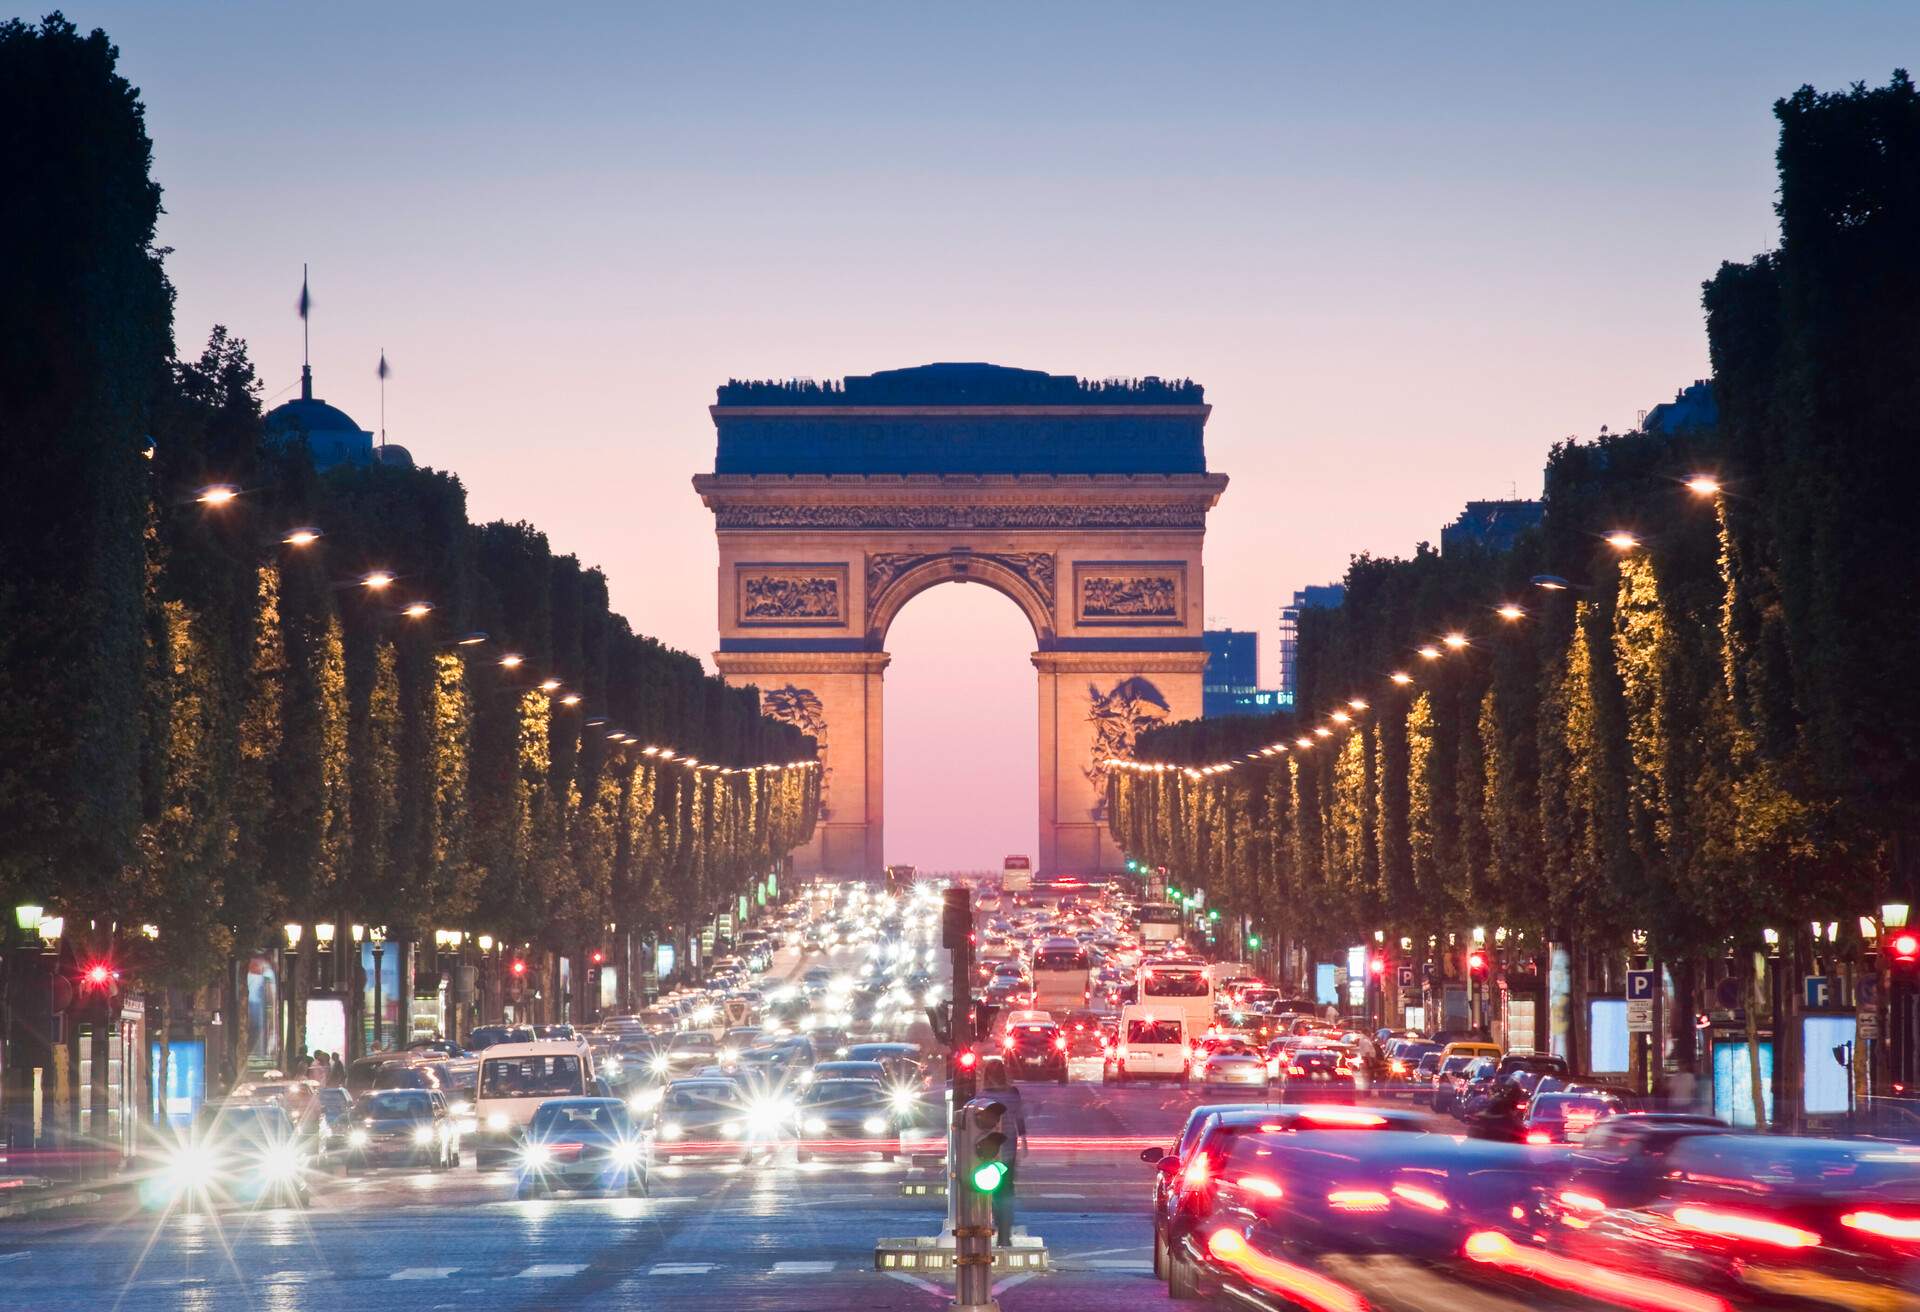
[{"left": 693, "top": 365, "right": 1227, "bottom": 876}]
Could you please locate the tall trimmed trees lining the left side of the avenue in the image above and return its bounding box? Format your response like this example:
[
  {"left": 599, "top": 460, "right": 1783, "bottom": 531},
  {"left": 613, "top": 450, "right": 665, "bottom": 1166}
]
[{"left": 0, "top": 17, "right": 820, "bottom": 1014}]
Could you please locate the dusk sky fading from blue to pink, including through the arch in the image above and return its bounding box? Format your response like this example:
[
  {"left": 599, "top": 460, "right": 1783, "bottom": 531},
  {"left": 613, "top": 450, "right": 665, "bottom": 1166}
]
[{"left": 67, "top": 0, "right": 1920, "bottom": 868}]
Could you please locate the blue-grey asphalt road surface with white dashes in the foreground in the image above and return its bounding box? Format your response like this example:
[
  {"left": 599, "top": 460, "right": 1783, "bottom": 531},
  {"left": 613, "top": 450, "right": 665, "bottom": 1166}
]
[{"left": 0, "top": 937, "right": 1196, "bottom": 1312}]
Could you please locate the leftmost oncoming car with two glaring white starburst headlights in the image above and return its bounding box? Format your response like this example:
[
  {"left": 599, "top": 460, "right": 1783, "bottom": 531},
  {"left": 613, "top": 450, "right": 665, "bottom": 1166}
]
[{"left": 140, "top": 1103, "right": 313, "bottom": 1210}]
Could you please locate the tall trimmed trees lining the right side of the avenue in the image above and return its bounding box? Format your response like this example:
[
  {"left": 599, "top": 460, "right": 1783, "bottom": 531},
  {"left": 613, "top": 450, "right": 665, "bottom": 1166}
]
[{"left": 1110, "top": 73, "right": 1920, "bottom": 983}]
